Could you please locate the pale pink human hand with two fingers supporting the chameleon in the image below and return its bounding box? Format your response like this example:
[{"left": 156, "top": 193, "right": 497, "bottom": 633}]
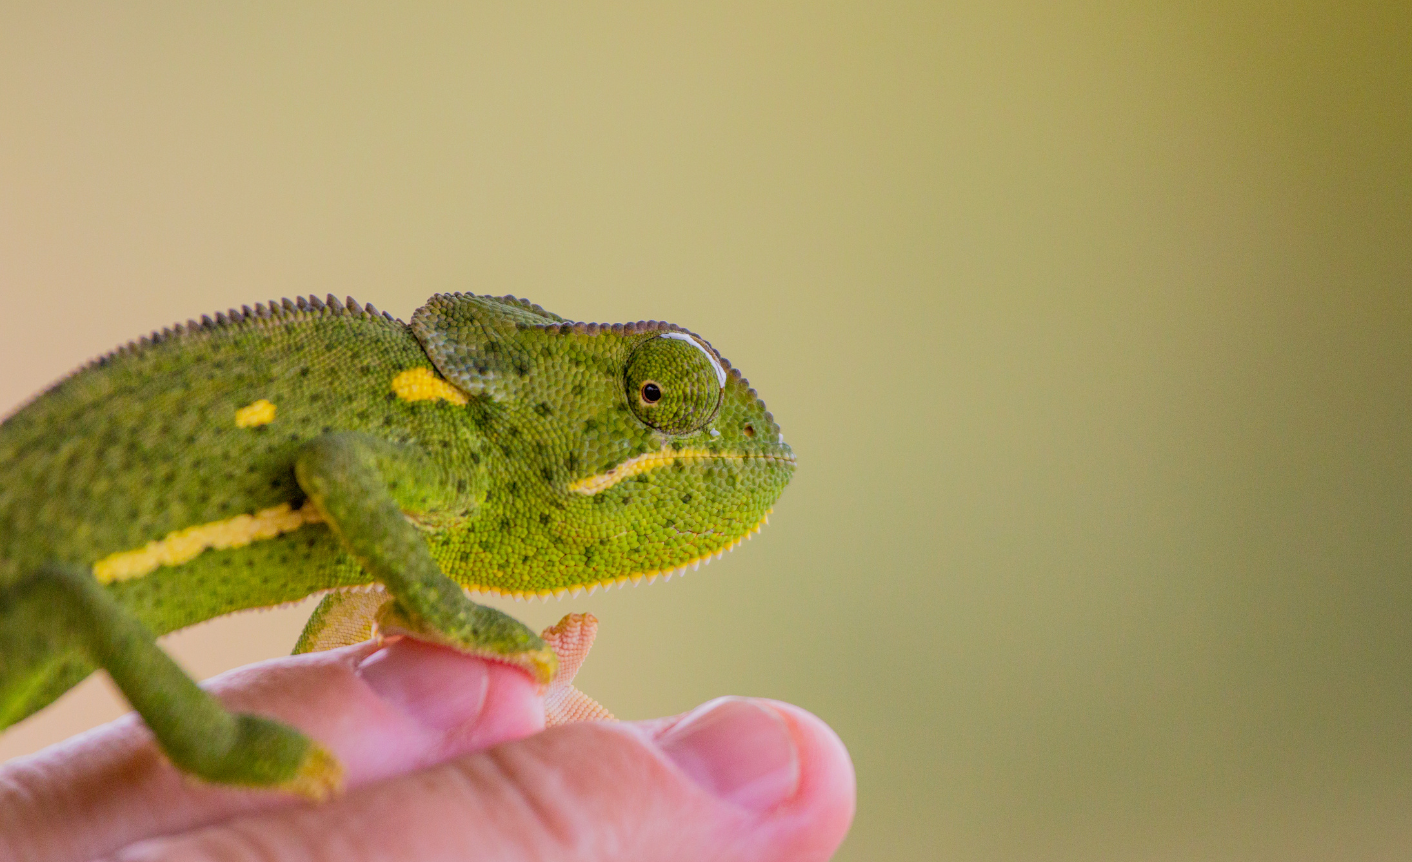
[{"left": 0, "top": 640, "right": 854, "bottom": 862}]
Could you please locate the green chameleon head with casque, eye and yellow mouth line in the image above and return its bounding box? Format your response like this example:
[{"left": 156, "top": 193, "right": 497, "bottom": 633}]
[{"left": 412, "top": 294, "right": 795, "bottom": 595}]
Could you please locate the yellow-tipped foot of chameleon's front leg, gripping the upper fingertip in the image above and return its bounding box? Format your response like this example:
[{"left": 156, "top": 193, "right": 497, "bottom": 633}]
[{"left": 377, "top": 601, "right": 559, "bottom": 688}]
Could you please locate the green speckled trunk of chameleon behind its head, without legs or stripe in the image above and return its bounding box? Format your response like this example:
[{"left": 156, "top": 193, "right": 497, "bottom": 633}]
[{"left": 0, "top": 302, "right": 463, "bottom": 633}]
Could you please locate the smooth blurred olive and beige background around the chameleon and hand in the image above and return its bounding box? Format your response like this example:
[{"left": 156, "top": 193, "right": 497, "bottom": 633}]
[{"left": 0, "top": 0, "right": 1412, "bottom": 861}]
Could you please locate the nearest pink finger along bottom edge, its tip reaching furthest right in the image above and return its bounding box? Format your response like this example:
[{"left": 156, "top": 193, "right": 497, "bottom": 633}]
[{"left": 107, "top": 698, "right": 854, "bottom": 862}]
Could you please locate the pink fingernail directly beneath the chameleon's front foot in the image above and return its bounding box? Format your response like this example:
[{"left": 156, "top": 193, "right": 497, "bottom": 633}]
[{"left": 357, "top": 639, "right": 490, "bottom": 731}]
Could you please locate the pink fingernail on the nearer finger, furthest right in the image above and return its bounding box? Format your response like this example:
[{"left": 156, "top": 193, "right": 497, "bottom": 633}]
[{"left": 657, "top": 698, "right": 799, "bottom": 811}]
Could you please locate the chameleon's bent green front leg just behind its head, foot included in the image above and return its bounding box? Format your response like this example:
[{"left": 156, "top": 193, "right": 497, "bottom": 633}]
[{"left": 294, "top": 432, "right": 558, "bottom": 685}]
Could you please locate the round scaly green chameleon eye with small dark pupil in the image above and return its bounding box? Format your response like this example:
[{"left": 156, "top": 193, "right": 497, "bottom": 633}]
[{"left": 624, "top": 332, "right": 726, "bottom": 434}]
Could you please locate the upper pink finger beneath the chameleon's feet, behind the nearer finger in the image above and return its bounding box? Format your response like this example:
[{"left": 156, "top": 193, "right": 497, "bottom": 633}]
[{"left": 0, "top": 640, "right": 544, "bottom": 861}]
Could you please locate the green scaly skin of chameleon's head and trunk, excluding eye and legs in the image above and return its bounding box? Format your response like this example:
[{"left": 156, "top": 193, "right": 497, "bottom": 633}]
[{"left": 0, "top": 294, "right": 794, "bottom": 633}]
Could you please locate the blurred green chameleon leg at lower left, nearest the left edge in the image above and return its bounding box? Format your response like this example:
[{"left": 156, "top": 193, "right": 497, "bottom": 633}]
[{"left": 0, "top": 564, "right": 342, "bottom": 798}]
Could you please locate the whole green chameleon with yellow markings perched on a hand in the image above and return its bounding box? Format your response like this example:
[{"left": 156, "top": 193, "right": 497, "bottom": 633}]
[{"left": 0, "top": 294, "right": 795, "bottom": 798}]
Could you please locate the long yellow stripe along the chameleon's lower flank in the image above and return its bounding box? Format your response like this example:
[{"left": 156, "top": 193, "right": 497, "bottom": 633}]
[{"left": 93, "top": 503, "right": 323, "bottom": 584}]
